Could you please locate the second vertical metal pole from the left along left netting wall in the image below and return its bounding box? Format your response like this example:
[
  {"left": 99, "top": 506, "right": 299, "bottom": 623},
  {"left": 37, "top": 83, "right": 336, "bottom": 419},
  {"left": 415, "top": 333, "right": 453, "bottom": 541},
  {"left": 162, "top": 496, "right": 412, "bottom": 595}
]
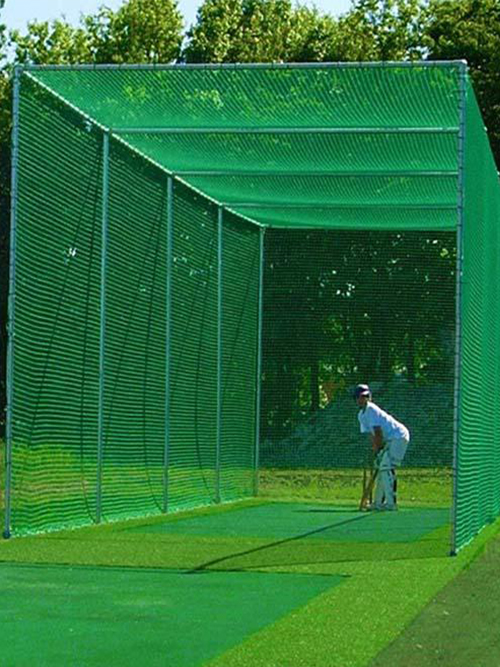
[{"left": 96, "top": 132, "right": 109, "bottom": 523}]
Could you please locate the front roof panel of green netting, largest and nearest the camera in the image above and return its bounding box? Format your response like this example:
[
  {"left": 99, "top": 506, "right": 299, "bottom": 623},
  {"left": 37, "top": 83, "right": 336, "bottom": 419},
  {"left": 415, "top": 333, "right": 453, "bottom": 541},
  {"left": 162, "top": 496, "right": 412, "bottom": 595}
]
[{"left": 28, "top": 63, "right": 460, "bottom": 129}]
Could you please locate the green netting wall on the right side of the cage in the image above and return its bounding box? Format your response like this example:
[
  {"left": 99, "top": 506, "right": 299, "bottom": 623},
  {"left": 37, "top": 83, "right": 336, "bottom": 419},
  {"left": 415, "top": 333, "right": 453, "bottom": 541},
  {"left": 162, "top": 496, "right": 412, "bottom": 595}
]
[{"left": 455, "top": 82, "right": 500, "bottom": 549}]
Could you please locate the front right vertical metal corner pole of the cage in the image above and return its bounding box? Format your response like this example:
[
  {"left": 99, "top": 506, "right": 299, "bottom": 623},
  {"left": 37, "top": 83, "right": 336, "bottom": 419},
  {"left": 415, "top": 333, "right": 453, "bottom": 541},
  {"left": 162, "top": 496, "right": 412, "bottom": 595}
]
[{"left": 451, "top": 62, "right": 467, "bottom": 555}]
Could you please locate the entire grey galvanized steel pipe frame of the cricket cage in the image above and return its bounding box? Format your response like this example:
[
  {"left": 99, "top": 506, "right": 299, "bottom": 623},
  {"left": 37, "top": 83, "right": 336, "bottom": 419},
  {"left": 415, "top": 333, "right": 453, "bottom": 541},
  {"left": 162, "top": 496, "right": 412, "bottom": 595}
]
[{"left": 4, "top": 61, "right": 467, "bottom": 536}]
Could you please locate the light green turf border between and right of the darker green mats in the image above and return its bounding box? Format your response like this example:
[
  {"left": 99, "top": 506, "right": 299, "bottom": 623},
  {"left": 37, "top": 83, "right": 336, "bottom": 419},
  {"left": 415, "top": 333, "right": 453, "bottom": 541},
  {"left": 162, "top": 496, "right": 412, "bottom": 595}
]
[{"left": 0, "top": 500, "right": 494, "bottom": 667}]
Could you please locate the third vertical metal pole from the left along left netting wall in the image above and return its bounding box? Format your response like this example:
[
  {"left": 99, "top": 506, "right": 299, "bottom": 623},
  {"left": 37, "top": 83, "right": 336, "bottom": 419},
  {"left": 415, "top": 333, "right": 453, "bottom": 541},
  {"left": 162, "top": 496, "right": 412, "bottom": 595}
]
[{"left": 163, "top": 176, "right": 174, "bottom": 513}]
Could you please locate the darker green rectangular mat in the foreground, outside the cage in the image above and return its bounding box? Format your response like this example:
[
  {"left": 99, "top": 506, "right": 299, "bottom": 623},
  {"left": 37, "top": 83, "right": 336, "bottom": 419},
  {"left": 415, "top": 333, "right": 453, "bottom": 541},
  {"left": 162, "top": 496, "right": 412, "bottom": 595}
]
[{"left": 0, "top": 565, "right": 342, "bottom": 667}]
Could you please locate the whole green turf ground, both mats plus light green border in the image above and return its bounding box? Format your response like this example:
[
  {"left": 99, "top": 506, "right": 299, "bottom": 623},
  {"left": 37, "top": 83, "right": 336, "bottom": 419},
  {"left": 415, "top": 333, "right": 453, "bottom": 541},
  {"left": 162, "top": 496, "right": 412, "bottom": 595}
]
[{"left": 0, "top": 501, "right": 500, "bottom": 667}]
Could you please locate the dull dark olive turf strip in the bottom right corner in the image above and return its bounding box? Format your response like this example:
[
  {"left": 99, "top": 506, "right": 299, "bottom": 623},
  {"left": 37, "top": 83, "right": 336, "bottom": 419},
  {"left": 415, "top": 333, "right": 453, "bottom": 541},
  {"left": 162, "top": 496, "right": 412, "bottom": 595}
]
[{"left": 370, "top": 536, "right": 500, "bottom": 667}]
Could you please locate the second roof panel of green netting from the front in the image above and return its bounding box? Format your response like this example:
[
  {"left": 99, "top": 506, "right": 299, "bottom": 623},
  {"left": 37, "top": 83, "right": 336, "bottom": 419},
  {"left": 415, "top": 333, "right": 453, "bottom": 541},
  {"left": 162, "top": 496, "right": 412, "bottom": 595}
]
[{"left": 121, "top": 131, "right": 458, "bottom": 177}]
